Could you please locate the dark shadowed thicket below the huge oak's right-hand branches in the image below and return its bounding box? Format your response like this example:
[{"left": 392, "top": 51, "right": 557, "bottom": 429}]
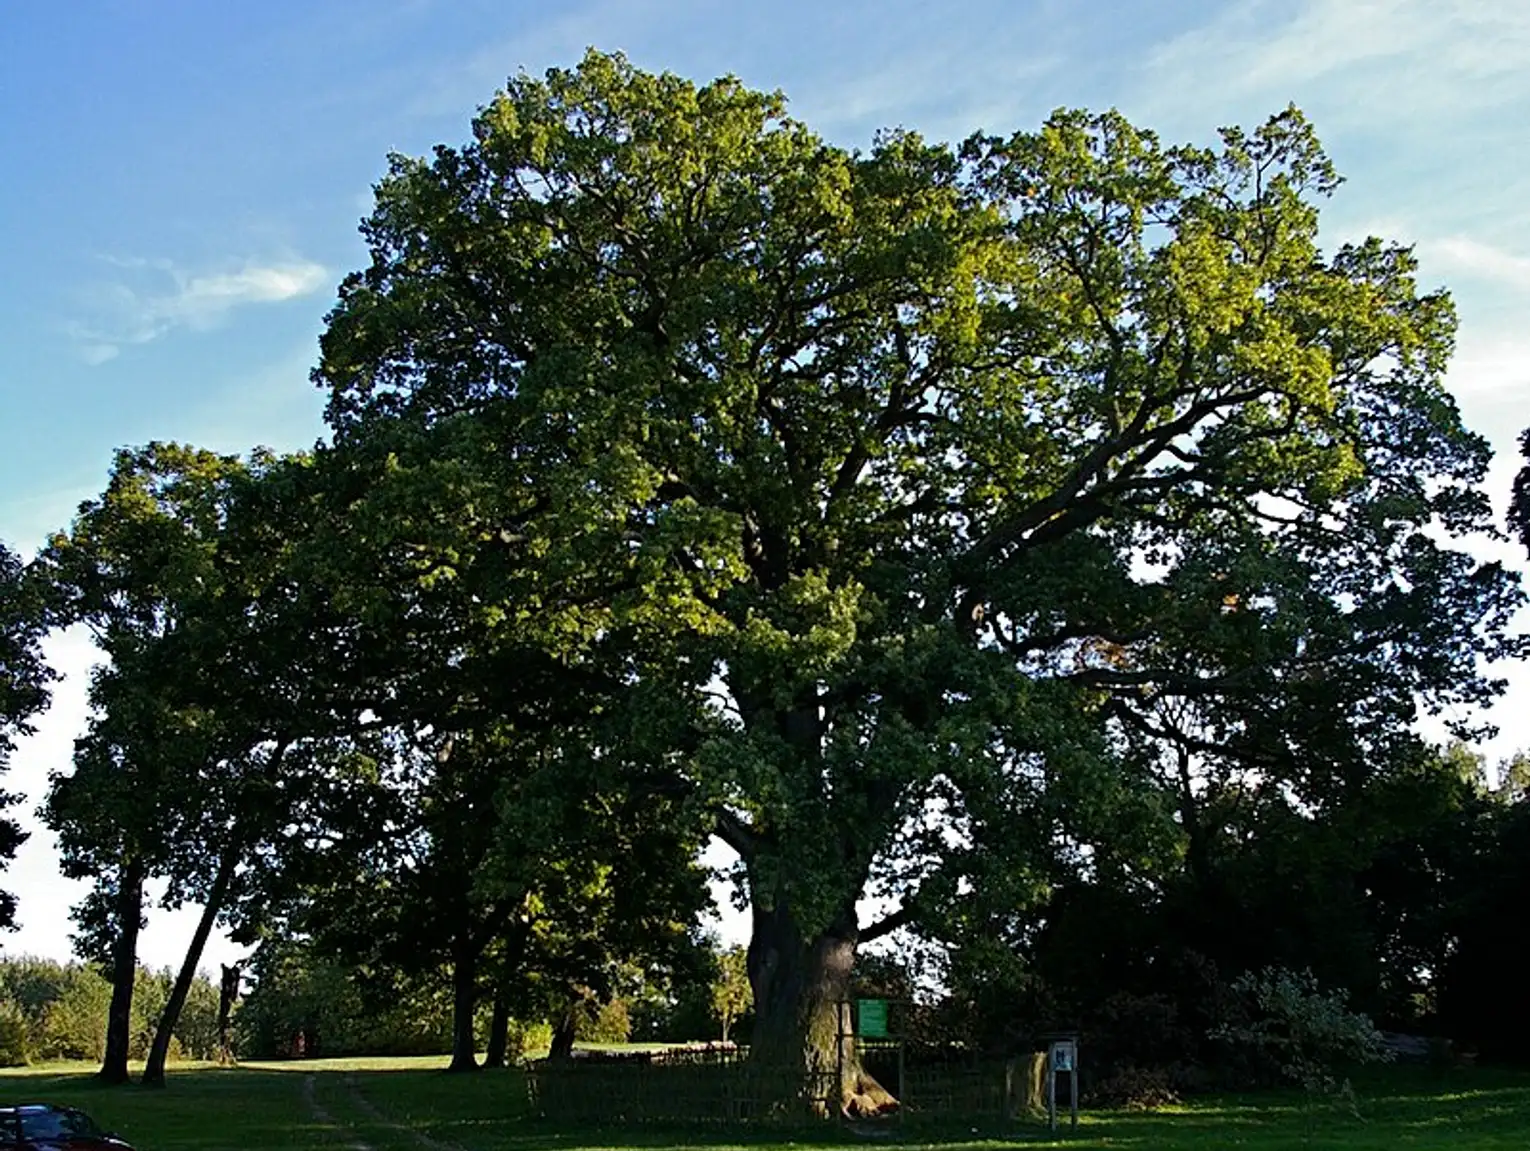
[{"left": 946, "top": 745, "right": 1521, "bottom": 1091}]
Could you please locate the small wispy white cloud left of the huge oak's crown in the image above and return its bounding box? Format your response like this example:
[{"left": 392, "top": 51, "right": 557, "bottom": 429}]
[{"left": 66, "top": 257, "right": 329, "bottom": 364}]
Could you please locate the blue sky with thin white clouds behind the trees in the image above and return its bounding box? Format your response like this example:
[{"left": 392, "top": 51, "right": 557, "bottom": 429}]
[{"left": 0, "top": 0, "right": 1530, "bottom": 963}]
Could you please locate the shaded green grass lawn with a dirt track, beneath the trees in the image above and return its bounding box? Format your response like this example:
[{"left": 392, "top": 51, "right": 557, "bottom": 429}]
[{"left": 0, "top": 1059, "right": 1530, "bottom": 1151}]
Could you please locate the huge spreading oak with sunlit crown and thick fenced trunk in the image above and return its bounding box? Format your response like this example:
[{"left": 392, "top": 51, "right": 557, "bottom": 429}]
[{"left": 315, "top": 54, "right": 1518, "bottom": 1108}]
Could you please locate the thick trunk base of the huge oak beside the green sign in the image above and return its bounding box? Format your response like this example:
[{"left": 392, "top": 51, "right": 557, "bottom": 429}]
[{"left": 748, "top": 902, "right": 898, "bottom": 1117}]
